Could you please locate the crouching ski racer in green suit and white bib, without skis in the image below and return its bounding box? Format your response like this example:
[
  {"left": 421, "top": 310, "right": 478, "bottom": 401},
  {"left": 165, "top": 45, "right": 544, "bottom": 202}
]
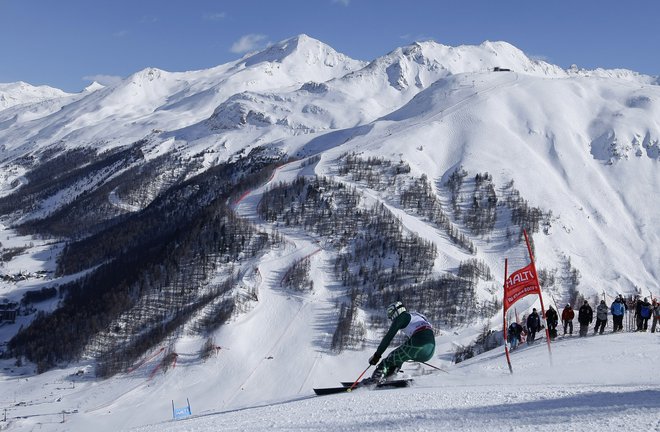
[{"left": 363, "top": 301, "right": 435, "bottom": 384}]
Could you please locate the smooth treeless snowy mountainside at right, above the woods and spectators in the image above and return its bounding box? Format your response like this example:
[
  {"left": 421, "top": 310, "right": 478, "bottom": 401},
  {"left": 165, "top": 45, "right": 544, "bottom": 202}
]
[{"left": 327, "top": 72, "right": 660, "bottom": 295}]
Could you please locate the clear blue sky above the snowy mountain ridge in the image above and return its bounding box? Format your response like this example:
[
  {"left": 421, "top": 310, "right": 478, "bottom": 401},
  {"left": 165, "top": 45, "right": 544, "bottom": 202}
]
[{"left": 0, "top": 0, "right": 660, "bottom": 92}]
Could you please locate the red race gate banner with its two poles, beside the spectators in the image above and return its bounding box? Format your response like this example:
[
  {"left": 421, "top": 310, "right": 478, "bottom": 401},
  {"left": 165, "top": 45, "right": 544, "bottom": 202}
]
[{"left": 502, "top": 230, "right": 552, "bottom": 373}]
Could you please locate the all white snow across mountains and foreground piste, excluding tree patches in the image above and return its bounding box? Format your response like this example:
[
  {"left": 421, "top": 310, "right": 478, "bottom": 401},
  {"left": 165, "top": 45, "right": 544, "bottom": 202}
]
[{"left": 0, "top": 35, "right": 660, "bottom": 432}]
